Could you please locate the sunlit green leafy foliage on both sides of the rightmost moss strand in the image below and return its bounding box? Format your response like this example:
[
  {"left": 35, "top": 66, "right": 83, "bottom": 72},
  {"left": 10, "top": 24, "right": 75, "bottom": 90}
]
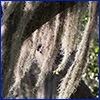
[{"left": 81, "top": 12, "right": 99, "bottom": 99}]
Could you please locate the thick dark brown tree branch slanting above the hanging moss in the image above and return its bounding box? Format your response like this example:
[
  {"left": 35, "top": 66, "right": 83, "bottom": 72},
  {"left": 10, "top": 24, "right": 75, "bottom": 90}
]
[{"left": 23, "top": 1, "right": 77, "bottom": 40}]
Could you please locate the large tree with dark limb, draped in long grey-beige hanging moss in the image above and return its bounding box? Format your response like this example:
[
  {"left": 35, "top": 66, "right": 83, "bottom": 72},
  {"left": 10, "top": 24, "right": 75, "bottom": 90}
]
[{"left": 1, "top": 1, "right": 99, "bottom": 99}]
